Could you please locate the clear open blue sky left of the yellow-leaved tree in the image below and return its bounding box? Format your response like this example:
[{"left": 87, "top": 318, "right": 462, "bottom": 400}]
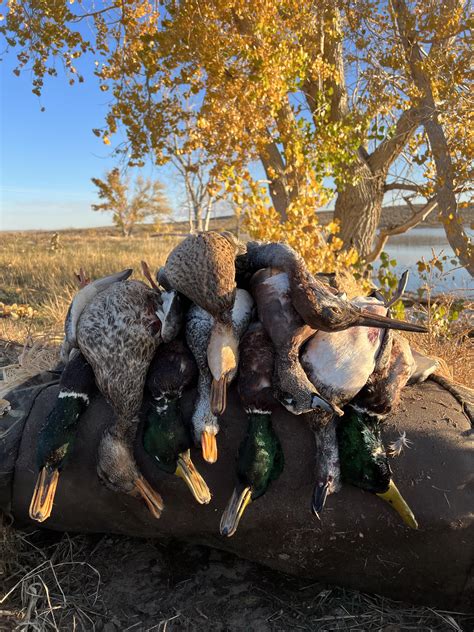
[{"left": 0, "top": 50, "right": 177, "bottom": 230}]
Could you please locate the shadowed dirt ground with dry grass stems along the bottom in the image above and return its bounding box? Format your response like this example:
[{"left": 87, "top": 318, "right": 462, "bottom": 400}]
[{"left": 0, "top": 528, "right": 474, "bottom": 632}]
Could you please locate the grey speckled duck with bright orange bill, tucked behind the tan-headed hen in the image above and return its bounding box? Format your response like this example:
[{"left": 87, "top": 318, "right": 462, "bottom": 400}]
[{"left": 186, "top": 289, "right": 253, "bottom": 463}]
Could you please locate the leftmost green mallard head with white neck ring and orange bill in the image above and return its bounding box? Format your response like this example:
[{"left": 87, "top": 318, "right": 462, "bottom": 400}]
[{"left": 30, "top": 350, "right": 95, "bottom": 522}]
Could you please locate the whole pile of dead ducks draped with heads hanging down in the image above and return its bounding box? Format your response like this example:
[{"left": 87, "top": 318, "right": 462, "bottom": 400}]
[{"left": 30, "top": 231, "right": 436, "bottom": 536}]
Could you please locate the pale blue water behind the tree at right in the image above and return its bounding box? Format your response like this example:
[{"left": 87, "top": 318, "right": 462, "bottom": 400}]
[{"left": 385, "top": 226, "right": 474, "bottom": 299}]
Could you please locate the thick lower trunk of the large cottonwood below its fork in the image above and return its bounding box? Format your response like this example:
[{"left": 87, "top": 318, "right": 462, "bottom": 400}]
[{"left": 334, "top": 158, "right": 385, "bottom": 258}]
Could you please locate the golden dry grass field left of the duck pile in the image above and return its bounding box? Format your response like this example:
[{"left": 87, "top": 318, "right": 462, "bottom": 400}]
[{"left": 0, "top": 231, "right": 181, "bottom": 344}]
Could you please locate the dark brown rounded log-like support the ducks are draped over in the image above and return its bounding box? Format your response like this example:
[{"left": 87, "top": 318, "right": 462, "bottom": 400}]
[{"left": 0, "top": 381, "right": 474, "bottom": 608}]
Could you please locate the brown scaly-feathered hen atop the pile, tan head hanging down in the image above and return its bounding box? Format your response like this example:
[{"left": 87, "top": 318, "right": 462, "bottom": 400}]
[{"left": 157, "top": 231, "right": 244, "bottom": 415}]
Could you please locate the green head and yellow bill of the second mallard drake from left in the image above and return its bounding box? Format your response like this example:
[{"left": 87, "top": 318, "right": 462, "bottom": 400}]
[{"left": 143, "top": 394, "right": 211, "bottom": 504}]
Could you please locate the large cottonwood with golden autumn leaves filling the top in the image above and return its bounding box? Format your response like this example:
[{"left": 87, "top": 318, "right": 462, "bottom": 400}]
[{"left": 2, "top": 0, "right": 472, "bottom": 271}]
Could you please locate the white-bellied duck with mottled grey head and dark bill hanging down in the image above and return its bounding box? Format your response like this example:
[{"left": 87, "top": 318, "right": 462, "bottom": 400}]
[{"left": 301, "top": 297, "right": 387, "bottom": 518}]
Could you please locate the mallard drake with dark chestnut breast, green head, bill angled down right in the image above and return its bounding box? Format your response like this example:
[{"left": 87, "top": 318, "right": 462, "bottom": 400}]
[{"left": 143, "top": 340, "right": 211, "bottom": 504}]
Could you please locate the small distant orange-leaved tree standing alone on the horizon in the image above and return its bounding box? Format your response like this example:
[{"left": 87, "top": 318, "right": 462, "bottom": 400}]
[{"left": 91, "top": 168, "right": 171, "bottom": 237}]
